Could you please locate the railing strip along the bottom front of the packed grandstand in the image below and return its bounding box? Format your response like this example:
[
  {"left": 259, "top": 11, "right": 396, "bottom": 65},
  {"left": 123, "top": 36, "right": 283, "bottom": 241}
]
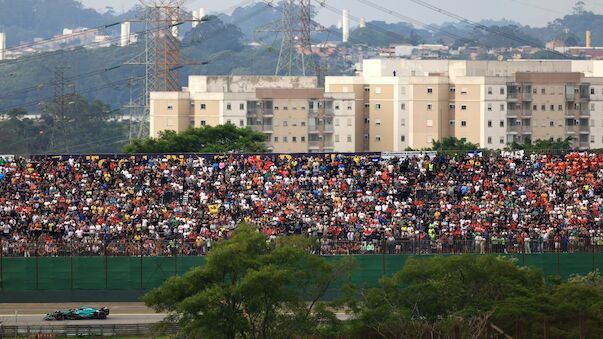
[{"left": 0, "top": 236, "right": 603, "bottom": 258}]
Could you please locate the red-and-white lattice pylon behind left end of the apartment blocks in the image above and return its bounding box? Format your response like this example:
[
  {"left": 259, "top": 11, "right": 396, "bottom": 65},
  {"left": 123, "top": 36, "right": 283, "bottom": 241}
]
[{"left": 126, "top": 0, "right": 184, "bottom": 138}]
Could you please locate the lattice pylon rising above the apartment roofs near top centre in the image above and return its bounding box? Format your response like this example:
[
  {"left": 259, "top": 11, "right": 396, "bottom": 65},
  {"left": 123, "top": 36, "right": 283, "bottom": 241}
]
[{"left": 257, "top": 0, "right": 326, "bottom": 75}]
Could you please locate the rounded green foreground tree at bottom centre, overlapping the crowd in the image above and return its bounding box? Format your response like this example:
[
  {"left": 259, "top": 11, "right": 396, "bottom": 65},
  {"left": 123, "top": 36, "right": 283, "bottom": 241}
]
[{"left": 144, "top": 225, "right": 349, "bottom": 338}]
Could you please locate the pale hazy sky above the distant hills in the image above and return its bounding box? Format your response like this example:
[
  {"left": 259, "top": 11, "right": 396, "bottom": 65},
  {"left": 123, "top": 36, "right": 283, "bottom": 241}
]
[{"left": 80, "top": 0, "right": 603, "bottom": 26}]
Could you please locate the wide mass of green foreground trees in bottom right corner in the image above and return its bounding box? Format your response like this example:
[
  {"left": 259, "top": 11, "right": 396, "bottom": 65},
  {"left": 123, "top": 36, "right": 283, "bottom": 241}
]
[{"left": 342, "top": 255, "right": 603, "bottom": 338}]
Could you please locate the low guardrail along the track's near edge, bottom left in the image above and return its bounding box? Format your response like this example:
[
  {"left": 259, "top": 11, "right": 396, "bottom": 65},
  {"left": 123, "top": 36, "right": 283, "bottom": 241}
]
[{"left": 0, "top": 324, "right": 178, "bottom": 338}]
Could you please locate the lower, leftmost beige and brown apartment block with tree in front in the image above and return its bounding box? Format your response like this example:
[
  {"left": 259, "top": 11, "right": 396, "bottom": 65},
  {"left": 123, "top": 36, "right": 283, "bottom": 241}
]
[{"left": 150, "top": 76, "right": 356, "bottom": 153}]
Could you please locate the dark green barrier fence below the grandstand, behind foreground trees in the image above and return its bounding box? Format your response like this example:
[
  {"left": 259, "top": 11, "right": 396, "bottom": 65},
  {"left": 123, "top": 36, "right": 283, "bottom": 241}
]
[{"left": 0, "top": 253, "right": 603, "bottom": 299}]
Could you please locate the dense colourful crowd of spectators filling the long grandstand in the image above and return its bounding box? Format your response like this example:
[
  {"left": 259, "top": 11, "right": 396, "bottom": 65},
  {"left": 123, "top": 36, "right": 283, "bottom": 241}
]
[{"left": 0, "top": 153, "right": 603, "bottom": 256}]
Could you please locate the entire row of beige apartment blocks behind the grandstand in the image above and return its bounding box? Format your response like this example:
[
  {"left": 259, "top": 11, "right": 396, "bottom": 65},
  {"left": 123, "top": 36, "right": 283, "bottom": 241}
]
[{"left": 151, "top": 59, "right": 603, "bottom": 152}]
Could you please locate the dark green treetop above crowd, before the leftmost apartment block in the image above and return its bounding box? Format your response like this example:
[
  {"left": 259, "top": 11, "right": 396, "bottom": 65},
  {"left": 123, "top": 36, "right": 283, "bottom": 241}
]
[{"left": 124, "top": 124, "right": 267, "bottom": 153}]
